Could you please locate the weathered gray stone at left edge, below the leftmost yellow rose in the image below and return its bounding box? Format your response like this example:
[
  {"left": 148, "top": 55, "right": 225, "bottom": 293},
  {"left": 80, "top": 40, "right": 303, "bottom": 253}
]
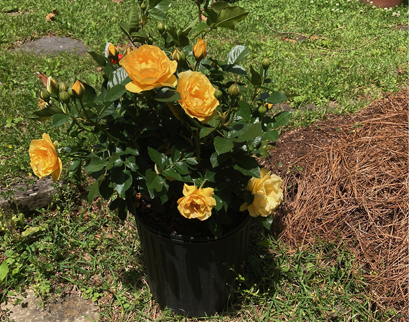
[{"left": 0, "top": 178, "right": 57, "bottom": 215}]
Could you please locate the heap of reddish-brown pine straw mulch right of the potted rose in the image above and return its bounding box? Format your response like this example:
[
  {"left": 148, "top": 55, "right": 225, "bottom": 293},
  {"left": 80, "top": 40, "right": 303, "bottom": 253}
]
[{"left": 262, "top": 89, "right": 409, "bottom": 313}]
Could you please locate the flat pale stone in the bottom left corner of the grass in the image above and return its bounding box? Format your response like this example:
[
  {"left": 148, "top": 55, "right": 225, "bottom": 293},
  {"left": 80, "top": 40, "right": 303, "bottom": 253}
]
[{"left": 2, "top": 290, "right": 99, "bottom": 322}]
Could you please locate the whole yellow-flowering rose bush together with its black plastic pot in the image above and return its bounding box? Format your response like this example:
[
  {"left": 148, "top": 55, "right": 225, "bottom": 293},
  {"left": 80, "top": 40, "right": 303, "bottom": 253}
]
[{"left": 29, "top": 0, "right": 290, "bottom": 316}]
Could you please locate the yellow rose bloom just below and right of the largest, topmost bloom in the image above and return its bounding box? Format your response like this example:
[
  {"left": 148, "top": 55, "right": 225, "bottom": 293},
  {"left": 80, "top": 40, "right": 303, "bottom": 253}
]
[{"left": 176, "top": 70, "right": 219, "bottom": 123}]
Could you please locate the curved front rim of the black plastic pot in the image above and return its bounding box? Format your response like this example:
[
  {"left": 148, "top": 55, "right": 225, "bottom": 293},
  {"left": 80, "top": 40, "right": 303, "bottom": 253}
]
[{"left": 135, "top": 214, "right": 252, "bottom": 243}]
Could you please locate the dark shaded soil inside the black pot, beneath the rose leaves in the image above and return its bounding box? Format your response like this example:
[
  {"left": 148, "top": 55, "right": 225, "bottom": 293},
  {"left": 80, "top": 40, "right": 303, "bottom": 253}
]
[{"left": 136, "top": 194, "right": 249, "bottom": 238}]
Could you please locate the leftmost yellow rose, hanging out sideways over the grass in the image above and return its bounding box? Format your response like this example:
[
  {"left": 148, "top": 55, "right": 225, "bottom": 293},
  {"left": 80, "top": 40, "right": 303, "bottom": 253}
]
[{"left": 29, "top": 133, "right": 62, "bottom": 182}]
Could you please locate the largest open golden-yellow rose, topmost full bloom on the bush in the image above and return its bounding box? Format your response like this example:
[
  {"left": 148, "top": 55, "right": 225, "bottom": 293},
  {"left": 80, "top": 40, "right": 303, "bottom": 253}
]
[{"left": 119, "top": 45, "right": 178, "bottom": 93}]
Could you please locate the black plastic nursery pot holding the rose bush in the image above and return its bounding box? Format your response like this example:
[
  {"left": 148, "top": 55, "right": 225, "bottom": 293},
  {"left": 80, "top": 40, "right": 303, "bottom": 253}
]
[{"left": 136, "top": 216, "right": 251, "bottom": 317}]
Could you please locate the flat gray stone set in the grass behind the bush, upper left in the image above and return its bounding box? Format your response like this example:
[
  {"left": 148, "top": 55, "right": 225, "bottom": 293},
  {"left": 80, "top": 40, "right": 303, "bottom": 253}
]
[{"left": 15, "top": 36, "right": 88, "bottom": 55}]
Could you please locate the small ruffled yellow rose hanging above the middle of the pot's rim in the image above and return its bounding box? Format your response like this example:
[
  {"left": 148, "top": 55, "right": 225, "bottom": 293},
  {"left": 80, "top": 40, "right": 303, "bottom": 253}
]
[{"left": 178, "top": 183, "right": 216, "bottom": 221}]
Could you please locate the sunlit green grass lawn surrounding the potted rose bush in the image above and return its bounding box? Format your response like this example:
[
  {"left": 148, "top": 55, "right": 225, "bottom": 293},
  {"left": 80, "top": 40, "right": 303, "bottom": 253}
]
[{"left": 0, "top": 0, "right": 409, "bottom": 321}]
